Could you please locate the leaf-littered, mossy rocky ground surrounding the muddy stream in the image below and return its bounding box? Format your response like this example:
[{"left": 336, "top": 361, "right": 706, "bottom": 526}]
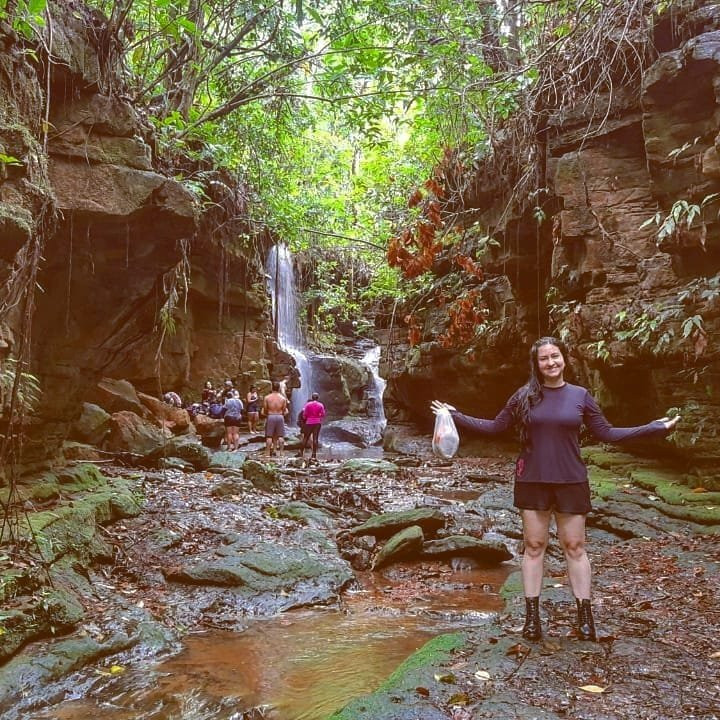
[{"left": 0, "top": 439, "right": 720, "bottom": 720}]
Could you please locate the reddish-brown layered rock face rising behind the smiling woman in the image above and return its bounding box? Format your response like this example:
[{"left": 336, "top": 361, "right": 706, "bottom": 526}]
[{"left": 381, "top": 6, "right": 720, "bottom": 473}]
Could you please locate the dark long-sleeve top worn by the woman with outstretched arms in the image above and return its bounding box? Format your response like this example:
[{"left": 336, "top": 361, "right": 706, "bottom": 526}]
[{"left": 451, "top": 383, "right": 667, "bottom": 483}]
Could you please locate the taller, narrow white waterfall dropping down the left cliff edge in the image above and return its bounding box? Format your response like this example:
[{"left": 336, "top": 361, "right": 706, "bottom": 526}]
[{"left": 265, "top": 245, "right": 312, "bottom": 425}]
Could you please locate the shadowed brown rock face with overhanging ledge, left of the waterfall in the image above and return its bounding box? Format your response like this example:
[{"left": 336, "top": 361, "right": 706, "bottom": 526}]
[{"left": 0, "top": 11, "right": 283, "bottom": 476}]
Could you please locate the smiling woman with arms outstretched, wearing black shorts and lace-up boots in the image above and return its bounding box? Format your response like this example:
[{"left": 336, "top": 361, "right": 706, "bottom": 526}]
[{"left": 432, "top": 337, "right": 680, "bottom": 640}]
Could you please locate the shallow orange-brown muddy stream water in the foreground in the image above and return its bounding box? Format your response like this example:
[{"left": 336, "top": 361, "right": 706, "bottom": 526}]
[{"left": 34, "top": 565, "right": 509, "bottom": 720}]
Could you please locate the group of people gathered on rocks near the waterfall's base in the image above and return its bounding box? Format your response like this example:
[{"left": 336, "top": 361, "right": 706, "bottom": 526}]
[{"left": 163, "top": 379, "right": 325, "bottom": 462}]
